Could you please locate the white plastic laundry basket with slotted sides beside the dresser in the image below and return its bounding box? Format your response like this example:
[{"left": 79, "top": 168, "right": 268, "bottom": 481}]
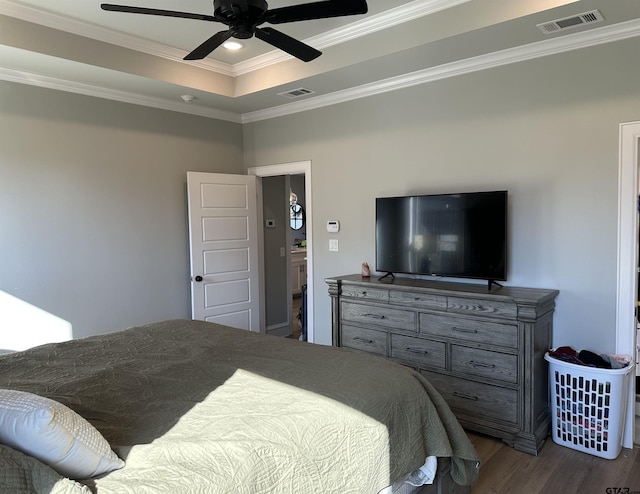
[{"left": 544, "top": 353, "right": 634, "bottom": 460}]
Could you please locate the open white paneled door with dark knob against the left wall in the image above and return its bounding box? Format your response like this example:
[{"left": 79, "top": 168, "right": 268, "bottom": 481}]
[{"left": 187, "top": 172, "right": 260, "bottom": 332}]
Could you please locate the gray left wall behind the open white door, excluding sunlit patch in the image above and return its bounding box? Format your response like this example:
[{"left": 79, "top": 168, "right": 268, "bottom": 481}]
[{"left": 0, "top": 82, "right": 245, "bottom": 337}]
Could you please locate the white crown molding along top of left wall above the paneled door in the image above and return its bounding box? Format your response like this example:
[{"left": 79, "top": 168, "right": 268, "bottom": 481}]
[{"left": 0, "top": 67, "right": 242, "bottom": 123}]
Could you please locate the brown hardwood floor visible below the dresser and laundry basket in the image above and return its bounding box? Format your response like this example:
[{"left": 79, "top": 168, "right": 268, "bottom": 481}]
[{"left": 468, "top": 432, "right": 640, "bottom": 494}]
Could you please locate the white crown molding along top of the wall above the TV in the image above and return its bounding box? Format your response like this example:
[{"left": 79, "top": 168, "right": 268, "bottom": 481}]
[{"left": 242, "top": 19, "right": 640, "bottom": 124}]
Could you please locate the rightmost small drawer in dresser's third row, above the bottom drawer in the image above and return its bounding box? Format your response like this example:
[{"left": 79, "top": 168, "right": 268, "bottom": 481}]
[{"left": 451, "top": 345, "right": 518, "bottom": 384}]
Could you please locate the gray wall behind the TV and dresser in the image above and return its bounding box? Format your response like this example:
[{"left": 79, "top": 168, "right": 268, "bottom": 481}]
[{"left": 243, "top": 38, "right": 640, "bottom": 351}]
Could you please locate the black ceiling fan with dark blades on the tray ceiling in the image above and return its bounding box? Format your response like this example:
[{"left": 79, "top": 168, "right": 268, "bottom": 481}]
[{"left": 101, "top": 0, "right": 368, "bottom": 62}]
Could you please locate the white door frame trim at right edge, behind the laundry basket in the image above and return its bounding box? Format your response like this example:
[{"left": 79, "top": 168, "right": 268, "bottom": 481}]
[{"left": 616, "top": 121, "right": 640, "bottom": 448}]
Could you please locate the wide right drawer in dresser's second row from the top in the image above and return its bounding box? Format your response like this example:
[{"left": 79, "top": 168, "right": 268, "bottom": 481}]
[{"left": 418, "top": 314, "right": 518, "bottom": 348}]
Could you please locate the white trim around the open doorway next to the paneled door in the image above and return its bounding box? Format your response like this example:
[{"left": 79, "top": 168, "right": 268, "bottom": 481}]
[{"left": 247, "top": 160, "right": 315, "bottom": 343}]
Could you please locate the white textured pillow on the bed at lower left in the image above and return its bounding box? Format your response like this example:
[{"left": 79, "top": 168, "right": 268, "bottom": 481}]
[{"left": 0, "top": 389, "right": 124, "bottom": 479}]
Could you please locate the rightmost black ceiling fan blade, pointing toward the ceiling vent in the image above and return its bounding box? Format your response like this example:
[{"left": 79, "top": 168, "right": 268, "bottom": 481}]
[{"left": 265, "top": 0, "right": 369, "bottom": 24}]
